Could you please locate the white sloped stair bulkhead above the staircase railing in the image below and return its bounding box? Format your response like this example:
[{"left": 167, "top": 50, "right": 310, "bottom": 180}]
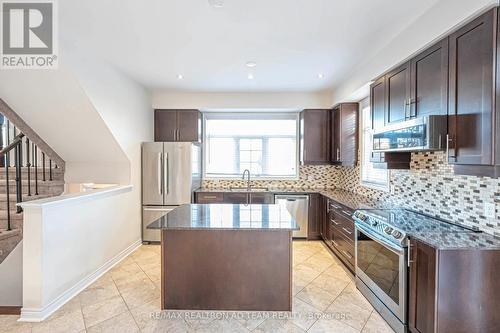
[{"left": 0, "top": 65, "right": 129, "bottom": 183}]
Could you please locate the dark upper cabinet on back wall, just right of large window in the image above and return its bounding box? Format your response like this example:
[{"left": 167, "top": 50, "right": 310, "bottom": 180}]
[{"left": 300, "top": 109, "right": 330, "bottom": 165}]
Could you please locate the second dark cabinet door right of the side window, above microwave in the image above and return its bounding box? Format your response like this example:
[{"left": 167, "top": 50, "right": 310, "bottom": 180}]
[{"left": 385, "top": 62, "right": 411, "bottom": 124}]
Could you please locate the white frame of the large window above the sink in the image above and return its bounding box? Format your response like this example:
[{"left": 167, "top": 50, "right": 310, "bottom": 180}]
[{"left": 202, "top": 110, "right": 300, "bottom": 181}]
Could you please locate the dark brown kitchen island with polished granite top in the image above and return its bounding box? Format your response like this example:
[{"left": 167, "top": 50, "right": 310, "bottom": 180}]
[{"left": 148, "top": 204, "right": 298, "bottom": 311}]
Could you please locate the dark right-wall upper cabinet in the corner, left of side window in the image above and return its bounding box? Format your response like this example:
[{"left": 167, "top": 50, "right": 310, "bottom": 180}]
[{"left": 330, "top": 103, "right": 359, "bottom": 166}]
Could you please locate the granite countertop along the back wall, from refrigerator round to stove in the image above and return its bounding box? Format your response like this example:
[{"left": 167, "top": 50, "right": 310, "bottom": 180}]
[{"left": 196, "top": 187, "right": 381, "bottom": 210}]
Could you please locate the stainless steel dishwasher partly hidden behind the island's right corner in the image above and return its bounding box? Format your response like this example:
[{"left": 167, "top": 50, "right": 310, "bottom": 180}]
[{"left": 274, "top": 194, "right": 309, "bottom": 238}]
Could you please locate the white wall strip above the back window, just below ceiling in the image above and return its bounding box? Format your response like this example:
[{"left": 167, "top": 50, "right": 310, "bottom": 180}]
[{"left": 153, "top": 91, "right": 332, "bottom": 109}]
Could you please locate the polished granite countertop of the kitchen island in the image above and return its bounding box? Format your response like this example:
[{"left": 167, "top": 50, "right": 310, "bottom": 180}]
[{"left": 148, "top": 204, "right": 299, "bottom": 231}]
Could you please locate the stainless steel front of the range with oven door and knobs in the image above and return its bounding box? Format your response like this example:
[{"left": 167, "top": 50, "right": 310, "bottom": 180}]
[{"left": 353, "top": 210, "right": 408, "bottom": 332}]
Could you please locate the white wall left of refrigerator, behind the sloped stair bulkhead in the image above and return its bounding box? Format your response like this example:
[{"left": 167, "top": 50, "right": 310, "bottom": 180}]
[{"left": 66, "top": 49, "right": 153, "bottom": 237}]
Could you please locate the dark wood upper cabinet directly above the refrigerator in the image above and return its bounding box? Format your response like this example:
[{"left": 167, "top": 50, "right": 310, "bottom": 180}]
[{"left": 154, "top": 110, "right": 202, "bottom": 142}]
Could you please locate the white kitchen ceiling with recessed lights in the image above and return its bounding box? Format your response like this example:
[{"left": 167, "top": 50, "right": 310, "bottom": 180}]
[{"left": 58, "top": 0, "right": 438, "bottom": 92}]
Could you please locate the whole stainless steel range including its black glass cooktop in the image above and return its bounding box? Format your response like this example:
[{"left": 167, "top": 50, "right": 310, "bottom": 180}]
[{"left": 353, "top": 209, "right": 475, "bottom": 332}]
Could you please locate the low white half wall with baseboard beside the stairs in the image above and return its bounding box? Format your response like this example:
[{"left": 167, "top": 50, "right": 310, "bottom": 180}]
[{"left": 21, "top": 186, "right": 141, "bottom": 321}]
